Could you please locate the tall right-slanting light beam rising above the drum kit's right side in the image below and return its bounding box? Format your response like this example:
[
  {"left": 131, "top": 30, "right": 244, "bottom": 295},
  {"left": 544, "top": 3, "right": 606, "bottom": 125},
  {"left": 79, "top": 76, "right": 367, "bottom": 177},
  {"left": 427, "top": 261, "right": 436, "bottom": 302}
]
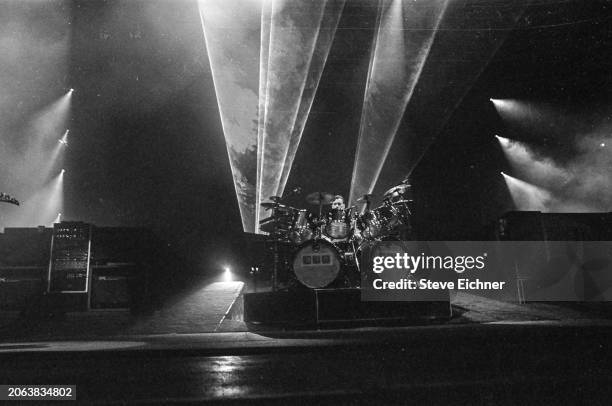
[{"left": 349, "top": 0, "right": 448, "bottom": 204}]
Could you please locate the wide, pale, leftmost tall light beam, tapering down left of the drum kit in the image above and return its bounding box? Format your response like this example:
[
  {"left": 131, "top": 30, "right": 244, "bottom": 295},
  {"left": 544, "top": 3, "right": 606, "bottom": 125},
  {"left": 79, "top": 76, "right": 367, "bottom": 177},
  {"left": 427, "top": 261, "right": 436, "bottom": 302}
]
[{"left": 198, "top": 0, "right": 261, "bottom": 232}]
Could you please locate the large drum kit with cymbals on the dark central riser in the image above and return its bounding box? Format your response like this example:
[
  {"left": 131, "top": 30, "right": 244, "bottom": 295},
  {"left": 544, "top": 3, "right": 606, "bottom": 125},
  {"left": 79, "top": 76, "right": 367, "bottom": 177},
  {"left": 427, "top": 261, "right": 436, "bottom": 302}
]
[{"left": 259, "top": 182, "right": 413, "bottom": 290}]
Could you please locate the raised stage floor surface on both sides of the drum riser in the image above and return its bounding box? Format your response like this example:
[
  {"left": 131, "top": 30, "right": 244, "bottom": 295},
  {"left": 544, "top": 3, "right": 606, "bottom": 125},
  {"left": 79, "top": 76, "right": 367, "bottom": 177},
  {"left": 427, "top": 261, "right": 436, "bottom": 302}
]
[{"left": 0, "top": 281, "right": 612, "bottom": 343}]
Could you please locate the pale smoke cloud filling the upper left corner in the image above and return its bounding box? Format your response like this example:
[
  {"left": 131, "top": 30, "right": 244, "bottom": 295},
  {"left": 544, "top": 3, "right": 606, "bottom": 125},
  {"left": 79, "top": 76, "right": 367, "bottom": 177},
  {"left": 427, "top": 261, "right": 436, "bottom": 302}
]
[{"left": 0, "top": 0, "right": 71, "bottom": 227}]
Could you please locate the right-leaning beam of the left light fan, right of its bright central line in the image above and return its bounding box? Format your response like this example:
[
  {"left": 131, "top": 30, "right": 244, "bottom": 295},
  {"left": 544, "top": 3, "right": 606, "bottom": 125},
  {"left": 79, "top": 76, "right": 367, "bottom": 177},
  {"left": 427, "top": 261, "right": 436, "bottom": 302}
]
[{"left": 258, "top": 0, "right": 342, "bottom": 230}]
